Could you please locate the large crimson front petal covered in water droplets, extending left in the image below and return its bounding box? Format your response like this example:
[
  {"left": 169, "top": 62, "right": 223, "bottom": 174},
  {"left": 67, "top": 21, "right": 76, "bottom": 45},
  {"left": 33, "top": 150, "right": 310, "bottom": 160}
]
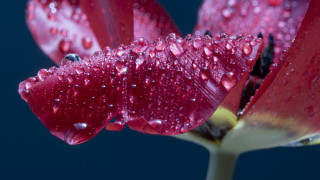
[{"left": 19, "top": 34, "right": 262, "bottom": 144}]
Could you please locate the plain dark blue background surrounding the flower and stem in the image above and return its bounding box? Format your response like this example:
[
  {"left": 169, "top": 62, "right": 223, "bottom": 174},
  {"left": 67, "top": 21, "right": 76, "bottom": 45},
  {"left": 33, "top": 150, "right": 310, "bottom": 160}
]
[{"left": 0, "top": 0, "right": 320, "bottom": 180}]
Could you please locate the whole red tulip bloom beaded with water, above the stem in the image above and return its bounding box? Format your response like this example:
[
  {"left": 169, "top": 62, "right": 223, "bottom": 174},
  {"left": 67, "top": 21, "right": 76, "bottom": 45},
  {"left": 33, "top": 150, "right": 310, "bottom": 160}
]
[{"left": 19, "top": 0, "right": 320, "bottom": 177}]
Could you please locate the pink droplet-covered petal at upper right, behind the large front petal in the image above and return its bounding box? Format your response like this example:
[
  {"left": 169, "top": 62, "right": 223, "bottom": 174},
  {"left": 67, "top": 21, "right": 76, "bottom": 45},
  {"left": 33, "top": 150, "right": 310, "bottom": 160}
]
[{"left": 196, "top": 0, "right": 309, "bottom": 62}]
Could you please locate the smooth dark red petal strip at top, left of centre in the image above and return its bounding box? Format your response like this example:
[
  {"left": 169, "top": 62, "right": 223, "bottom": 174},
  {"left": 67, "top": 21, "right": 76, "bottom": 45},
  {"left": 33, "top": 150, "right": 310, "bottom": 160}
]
[{"left": 80, "top": 0, "right": 133, "bottom": 48}]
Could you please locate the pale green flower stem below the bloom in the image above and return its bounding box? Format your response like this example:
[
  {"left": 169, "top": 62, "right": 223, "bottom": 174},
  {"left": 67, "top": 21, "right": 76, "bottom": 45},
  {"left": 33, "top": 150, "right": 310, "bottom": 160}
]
[{"left": 207, "top": 150, "right": 238, "bottom": 180}]
